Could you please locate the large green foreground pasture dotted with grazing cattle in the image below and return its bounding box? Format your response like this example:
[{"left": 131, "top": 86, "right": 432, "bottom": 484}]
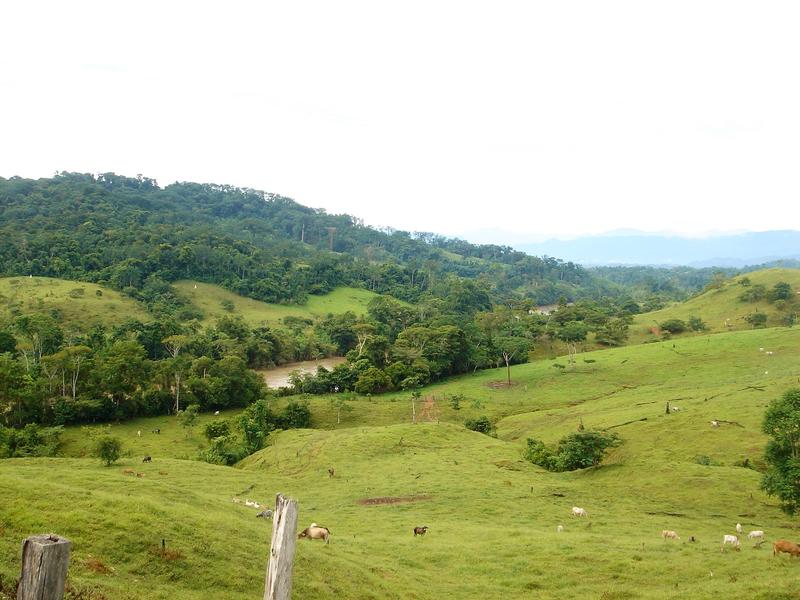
[{"left": 6, "top": 328, "right": 800, "bottom": 599}]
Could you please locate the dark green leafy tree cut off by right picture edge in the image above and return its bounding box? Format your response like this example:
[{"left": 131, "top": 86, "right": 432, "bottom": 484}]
[{"left": 761, "top": 388, "right": 800, "bottom": 515}]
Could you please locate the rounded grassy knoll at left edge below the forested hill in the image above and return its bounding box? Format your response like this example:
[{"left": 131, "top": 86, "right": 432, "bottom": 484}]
[{"left": 0, "top": 277, "right": 149, "bottom": 331}]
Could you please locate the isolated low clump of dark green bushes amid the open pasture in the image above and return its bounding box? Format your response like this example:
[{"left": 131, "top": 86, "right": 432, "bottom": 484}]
[{"left": 523, "top": 429, "right": 622, "bottom": 472}]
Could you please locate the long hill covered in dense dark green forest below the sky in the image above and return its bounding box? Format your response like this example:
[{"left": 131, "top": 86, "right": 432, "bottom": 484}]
[{"left": 0, "top": 173, "right": 597, "bottom": 303}]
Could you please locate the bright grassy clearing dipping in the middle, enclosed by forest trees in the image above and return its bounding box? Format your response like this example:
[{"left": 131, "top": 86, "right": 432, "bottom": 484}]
[{"left": 174, "top": 281, "right": 388, "bottom": 325}]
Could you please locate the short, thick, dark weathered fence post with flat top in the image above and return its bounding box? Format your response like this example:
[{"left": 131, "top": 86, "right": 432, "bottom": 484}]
[{"left": 17, "top": 533, "right": 72, "bottom": 600}]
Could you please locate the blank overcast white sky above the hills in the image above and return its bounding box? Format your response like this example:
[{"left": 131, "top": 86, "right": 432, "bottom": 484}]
[{"left": 0, "top": 0, "right": 800, "bottom": 242}]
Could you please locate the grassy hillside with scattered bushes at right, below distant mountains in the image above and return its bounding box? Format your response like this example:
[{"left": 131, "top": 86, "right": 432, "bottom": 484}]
[{"left": 630, "top": 269, "right": 800, "bottom": 343}]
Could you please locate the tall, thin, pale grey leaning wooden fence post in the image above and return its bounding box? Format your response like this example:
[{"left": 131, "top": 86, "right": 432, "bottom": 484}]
[{"left": 264, "top": 494, "right": 297, "bottom": 600}]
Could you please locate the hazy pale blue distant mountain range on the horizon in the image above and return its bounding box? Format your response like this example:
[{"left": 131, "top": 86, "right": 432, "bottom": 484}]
[{"left": 514, "top": 230, "right": 800, "bottom": 268}]
